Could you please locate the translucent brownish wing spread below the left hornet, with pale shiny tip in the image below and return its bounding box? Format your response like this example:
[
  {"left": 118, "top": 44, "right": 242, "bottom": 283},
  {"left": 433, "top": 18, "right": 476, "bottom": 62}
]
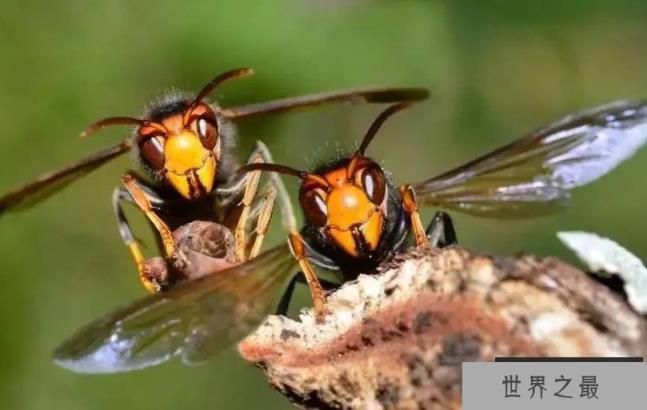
[{"left": 54, "top": 244, "right": 297, "bottom": 373}]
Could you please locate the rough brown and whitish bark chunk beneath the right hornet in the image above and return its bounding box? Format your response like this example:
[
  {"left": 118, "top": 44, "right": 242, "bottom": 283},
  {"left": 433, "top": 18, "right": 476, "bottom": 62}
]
[{"left": 239, "top": 247, "right": 647, "bottom": 409}]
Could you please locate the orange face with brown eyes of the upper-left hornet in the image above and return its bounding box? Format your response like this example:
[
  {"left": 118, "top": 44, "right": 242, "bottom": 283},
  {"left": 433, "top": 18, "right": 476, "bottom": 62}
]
[{"left": 137, "top": 104, "right": 220, "bottom": 199}]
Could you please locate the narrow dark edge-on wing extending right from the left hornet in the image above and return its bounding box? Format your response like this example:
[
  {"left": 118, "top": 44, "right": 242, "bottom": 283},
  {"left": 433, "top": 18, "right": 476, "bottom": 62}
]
[{"left": 222, "top": 87, "right": 429, "bottom": 118}]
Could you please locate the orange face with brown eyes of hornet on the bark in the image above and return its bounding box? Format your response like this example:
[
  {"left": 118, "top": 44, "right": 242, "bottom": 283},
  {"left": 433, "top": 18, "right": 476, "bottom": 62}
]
[{"left": 299, "top": 156, "right": 387, "bottom": 257}]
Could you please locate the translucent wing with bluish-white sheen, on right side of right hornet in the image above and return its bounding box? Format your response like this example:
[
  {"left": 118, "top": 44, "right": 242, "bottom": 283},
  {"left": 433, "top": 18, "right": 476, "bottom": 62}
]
[{"left": 411, "top": 101, "right": 647, "bottom": 217}]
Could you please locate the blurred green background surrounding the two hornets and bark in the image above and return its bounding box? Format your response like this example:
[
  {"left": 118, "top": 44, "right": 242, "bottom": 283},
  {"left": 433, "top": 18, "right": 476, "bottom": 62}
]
[{"left": 0, "top": 0, "right": 647, "bottom": 410}]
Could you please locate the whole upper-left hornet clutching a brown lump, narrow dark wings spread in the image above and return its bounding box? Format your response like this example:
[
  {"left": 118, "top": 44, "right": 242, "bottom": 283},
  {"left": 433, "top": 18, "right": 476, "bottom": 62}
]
[{"left": 0, "top": 68, "right": 428, "bottom": 292}]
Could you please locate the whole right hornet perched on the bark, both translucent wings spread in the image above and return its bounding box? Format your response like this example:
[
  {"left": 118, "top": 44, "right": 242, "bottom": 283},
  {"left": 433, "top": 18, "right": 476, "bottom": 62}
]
[{"left": 54, "top": 101, "right": 647, "bottom": 373}]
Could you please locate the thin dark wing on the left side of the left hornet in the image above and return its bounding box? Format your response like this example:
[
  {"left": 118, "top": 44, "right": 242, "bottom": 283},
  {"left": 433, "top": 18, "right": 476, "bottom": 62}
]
[{"left": 0, "top": 140, "right": 131, "bottom": 215}]
